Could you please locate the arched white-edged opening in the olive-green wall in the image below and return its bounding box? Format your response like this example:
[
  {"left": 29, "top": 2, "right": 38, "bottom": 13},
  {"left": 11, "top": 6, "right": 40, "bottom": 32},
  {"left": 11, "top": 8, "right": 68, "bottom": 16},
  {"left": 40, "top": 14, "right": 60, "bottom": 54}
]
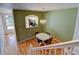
[{"left": 25, "top": 15, "right": 38, "bottom": 28}]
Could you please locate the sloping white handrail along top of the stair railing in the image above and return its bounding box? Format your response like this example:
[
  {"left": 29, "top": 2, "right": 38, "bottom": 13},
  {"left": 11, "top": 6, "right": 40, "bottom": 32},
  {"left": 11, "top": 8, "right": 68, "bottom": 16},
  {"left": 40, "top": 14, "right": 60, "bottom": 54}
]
[{"left": 31, "top": 40, "right": 79, "bottom": 50}]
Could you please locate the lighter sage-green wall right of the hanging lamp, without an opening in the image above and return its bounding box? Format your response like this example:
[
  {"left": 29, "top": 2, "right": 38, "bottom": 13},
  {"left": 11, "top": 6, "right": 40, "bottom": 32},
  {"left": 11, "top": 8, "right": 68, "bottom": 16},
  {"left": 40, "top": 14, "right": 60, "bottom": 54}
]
[{"left": 43, "top": 8, "right": 77, "bottom": 41}]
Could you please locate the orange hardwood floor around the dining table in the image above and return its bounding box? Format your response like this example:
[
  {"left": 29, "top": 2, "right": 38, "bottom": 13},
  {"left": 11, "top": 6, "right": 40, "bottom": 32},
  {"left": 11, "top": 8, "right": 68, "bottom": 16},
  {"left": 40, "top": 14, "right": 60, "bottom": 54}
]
[{"left": 18, "top": 38, "right": 61, "bottom": 55}]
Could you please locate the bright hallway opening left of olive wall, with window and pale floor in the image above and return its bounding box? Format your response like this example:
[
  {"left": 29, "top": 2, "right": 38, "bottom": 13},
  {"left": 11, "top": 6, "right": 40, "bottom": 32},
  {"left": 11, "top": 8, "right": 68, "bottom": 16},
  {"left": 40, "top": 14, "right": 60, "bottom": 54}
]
[{"left": 0, "top": 12, "right": 18, "bottom": 55}]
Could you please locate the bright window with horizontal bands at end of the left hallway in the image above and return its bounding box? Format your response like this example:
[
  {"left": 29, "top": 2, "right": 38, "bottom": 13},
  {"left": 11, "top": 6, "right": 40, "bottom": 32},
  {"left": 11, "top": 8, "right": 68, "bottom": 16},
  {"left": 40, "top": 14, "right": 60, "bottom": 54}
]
[{"left": 5, "top": 15, "right": 14, "bottom": 30}]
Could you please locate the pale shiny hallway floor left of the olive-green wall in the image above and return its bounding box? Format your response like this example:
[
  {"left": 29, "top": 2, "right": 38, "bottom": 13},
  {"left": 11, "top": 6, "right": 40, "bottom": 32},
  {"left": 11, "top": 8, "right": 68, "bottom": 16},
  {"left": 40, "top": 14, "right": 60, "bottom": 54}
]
[{"left": 3, "top": 33, "right": 19, "bottom": 55}]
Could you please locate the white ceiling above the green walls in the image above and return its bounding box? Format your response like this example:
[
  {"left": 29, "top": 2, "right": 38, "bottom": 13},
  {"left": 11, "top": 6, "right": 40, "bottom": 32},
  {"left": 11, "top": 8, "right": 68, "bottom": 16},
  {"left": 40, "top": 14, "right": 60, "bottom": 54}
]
[{"left": 0, "top": 3, "right": 79, "bottom": 11}]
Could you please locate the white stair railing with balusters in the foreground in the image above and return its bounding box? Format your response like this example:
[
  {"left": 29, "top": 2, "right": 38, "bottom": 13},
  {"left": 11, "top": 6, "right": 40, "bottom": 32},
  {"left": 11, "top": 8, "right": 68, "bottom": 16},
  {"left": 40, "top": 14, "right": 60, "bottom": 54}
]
[{"left": 28, "top": 40, "right": 79, "bottom": 55}]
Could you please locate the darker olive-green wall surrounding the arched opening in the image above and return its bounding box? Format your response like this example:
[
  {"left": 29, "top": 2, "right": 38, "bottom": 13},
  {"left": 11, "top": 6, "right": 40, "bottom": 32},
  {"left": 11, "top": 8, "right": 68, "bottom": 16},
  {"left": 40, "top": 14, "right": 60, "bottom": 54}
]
[{"left": 13, "top": 9, "right": 42, "bottom": 42}]
